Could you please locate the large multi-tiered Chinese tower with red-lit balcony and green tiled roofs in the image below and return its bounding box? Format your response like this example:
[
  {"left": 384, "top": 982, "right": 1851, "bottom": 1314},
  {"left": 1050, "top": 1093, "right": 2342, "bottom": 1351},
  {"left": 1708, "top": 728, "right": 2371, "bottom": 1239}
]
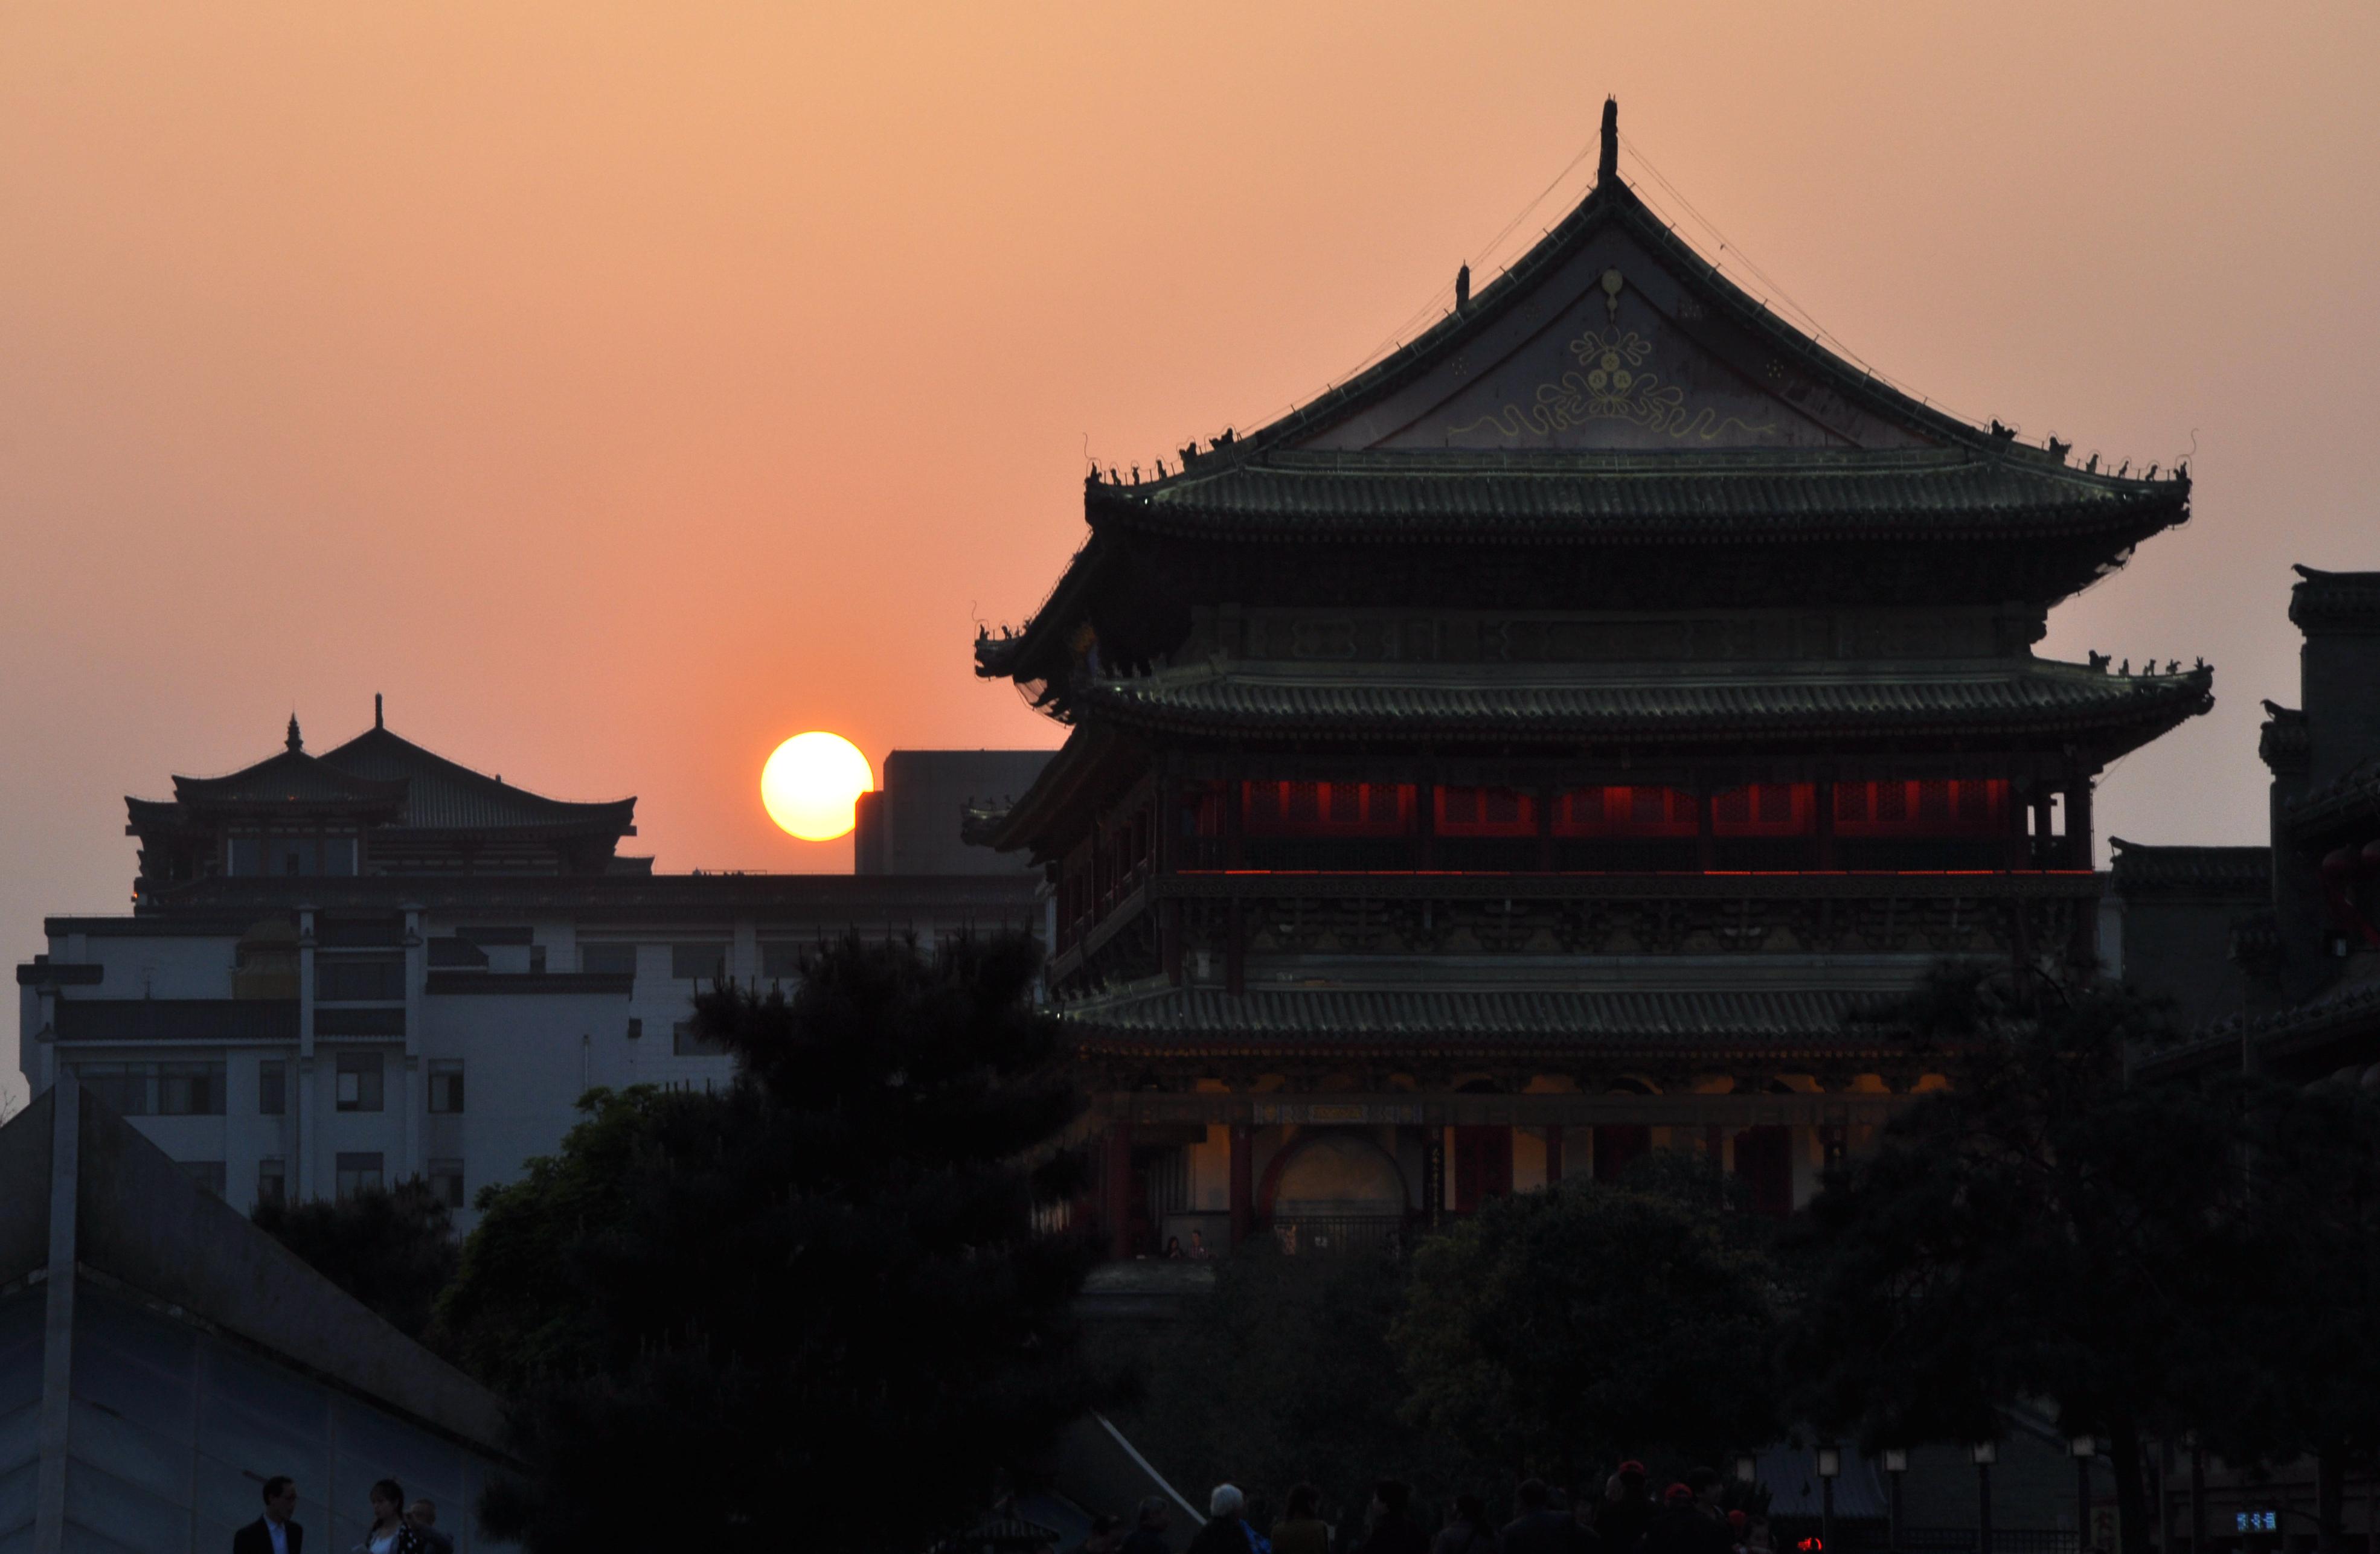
[{"left": 971, "top": 104, "right": 2211, "bottom": 1254}]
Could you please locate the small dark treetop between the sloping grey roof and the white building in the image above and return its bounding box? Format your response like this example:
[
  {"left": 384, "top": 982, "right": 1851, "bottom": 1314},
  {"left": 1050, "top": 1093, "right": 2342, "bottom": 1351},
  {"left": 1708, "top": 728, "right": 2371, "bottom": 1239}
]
[{"left": 255, "top": 1178, "right": 460, "bottom": 1342}]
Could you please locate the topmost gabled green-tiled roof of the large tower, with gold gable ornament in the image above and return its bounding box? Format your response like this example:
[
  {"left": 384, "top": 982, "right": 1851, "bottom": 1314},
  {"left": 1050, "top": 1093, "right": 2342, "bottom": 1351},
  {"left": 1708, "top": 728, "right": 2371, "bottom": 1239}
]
[{"left": 976, "top": 106, "right": 2190, "bottom": 680}]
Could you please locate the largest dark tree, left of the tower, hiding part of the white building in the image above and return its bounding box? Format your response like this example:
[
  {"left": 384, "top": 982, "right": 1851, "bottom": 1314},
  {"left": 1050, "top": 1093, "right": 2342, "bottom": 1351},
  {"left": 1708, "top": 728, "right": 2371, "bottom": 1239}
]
[{"left": 440, "top": 940, "right": 1088, "bottom": 1552}]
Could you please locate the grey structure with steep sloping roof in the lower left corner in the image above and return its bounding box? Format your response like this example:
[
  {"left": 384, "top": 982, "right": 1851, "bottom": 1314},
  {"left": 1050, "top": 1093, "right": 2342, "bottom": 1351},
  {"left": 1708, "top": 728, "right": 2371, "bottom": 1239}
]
[{"left": 0, "top": 1069, "right": 512, "bottom": 1554}]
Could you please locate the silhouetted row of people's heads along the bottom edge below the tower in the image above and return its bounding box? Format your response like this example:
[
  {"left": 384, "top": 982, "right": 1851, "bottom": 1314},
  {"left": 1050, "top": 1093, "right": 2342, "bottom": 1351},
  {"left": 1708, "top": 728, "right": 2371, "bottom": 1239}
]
[{"left": 1083, "top": 1461, "right": 1771, "bottom": 1554}]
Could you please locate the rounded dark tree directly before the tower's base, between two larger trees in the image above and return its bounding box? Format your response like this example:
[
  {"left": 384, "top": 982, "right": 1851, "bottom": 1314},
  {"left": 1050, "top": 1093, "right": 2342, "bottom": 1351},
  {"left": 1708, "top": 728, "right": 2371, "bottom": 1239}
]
[{"left": 1392, "top": 1154, "right": 1783, "bottom": 1483}]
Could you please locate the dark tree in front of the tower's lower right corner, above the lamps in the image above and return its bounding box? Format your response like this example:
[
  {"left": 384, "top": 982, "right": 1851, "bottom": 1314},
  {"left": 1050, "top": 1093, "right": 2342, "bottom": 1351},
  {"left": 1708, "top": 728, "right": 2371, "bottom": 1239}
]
[{"left": 1788, "top": 971, "right": 2239, "bottom": 1554}]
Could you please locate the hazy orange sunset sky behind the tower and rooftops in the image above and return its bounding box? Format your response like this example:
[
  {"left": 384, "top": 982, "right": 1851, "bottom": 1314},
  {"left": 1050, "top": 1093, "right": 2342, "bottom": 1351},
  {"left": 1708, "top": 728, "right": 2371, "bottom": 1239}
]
[{"left": 0, "top": 0, "right": 2380, "bottom": 1066}]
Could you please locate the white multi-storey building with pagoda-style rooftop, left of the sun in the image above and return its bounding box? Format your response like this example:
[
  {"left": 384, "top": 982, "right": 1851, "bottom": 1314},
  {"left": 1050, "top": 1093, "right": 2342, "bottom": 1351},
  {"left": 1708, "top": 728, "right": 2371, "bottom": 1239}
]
[{"left": 17, "top": 716, "right": 1042, "bottom": 1223}]
